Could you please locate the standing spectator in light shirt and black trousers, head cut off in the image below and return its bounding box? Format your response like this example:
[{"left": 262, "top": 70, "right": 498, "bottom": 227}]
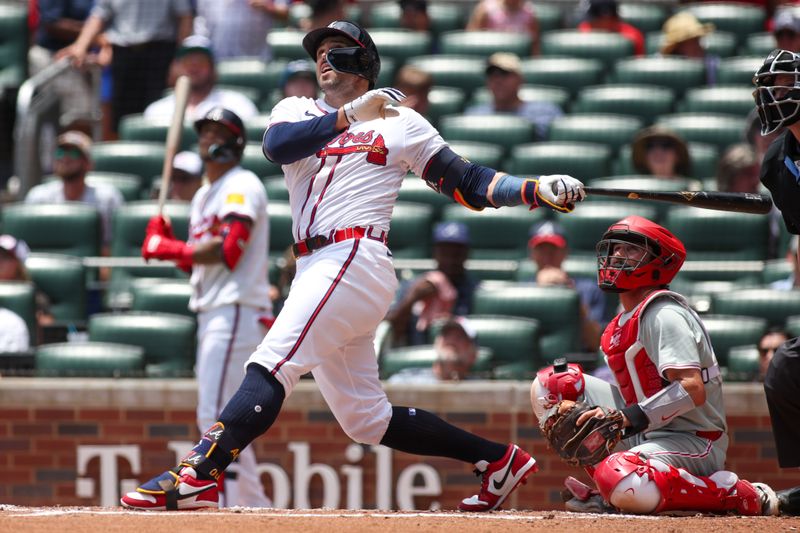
[{"left": 59, "top": 0, "right": 192, "bottom": 135}]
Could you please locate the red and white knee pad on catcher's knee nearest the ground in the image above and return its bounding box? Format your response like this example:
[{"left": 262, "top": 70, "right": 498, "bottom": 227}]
[{"left": 593, "top": 452, "right": 667, "bottom": 514}]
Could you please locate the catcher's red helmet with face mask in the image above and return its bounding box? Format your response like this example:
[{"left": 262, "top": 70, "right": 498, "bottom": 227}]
[{"left": 597, "top": 216, "right": 686, "bottom": 292}]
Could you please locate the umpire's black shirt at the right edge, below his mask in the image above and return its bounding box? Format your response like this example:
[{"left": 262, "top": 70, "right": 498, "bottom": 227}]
[{"left": 761, "top": 130, "right": 800, "bottom": 235}]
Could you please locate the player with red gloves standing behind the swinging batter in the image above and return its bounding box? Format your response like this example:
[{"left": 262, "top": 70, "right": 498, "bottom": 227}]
[{"left": 142, "top": 107, "right": 272, "bottom": 507}]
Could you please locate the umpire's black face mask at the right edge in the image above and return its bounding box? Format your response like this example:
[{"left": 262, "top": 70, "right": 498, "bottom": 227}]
[{"left": 753, "top": 50, "right": 800, "bottom": 135}]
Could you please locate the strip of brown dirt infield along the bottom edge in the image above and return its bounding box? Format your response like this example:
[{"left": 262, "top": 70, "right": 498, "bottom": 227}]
[{"left": 0, "top": 505, "right": 800, "bottom": 533}]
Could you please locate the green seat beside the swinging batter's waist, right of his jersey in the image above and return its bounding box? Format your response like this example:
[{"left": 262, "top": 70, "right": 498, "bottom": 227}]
[{"left": 389, "top": 202, "right": 436, "bottom": 258}]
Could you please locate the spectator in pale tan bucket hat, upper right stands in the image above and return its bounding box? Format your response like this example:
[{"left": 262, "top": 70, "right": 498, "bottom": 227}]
[{"left": 661, "top": 11, "right": 720, "bottom": 85}]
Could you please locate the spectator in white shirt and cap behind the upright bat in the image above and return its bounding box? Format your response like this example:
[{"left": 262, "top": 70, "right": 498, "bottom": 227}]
[{"left": 144, "top": 35, "right": 258, "bottom": 123}]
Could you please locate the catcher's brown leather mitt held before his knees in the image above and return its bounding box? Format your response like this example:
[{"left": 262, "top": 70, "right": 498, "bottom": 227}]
[{"left": 542, "top": 400, "right": 623, "bottom": 466}]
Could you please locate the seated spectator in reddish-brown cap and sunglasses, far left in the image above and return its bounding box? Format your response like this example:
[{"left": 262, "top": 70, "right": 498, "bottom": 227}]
[{"left": 25, "top": 130, "right": 123, "bottom": 255}]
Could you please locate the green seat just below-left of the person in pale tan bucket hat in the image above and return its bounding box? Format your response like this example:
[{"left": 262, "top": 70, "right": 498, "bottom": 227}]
[{"left": 608, "top": 56, "right": 706, "bottom": 98}]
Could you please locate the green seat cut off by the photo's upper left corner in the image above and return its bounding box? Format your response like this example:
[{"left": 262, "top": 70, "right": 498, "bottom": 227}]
[{"left": 0, "top": 2, "right": 30, "bottom": 89}]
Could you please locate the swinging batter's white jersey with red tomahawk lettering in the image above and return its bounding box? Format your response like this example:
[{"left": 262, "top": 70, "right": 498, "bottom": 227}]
[{"left": 268, "top": 97, "right": 446, "bottom": 241}]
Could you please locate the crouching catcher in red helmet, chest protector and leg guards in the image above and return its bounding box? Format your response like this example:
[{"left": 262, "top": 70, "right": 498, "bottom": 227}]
[{"left": 531, "top": 216, "right": 797, "bottom": 515}]
